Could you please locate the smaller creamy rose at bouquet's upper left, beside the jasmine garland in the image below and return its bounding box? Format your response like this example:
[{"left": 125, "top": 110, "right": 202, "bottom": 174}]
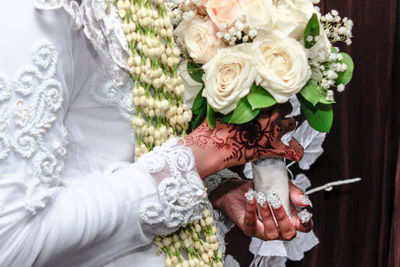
[{"left": 175, "top": 17, "right": 224, "bottom": 64}]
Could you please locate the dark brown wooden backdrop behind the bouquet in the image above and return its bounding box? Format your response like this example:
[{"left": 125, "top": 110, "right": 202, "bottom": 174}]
[{"left": 227, "top": 0, "right": 400, "bottom": 267}]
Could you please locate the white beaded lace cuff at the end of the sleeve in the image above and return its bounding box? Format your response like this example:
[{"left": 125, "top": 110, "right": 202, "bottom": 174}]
[{"left": 137, "top": 138, "right": 207, "bottom": 234}]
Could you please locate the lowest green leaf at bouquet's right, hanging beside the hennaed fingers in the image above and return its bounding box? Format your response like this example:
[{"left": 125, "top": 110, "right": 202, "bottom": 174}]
[{"left": 297, "top": 94, "right": 333, "bottom": 133}]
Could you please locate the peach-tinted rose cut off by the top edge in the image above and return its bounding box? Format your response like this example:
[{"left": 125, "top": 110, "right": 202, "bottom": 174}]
[{"left": 205, "top": 0, "right": 247, "bottom": 29}]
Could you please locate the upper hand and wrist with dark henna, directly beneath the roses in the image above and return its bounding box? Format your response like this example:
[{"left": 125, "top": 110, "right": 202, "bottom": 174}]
[{"left": 185, "top": 109, "right": 303, "bottom": 177}]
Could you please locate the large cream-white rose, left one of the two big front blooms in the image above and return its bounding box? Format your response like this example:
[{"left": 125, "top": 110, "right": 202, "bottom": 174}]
[{"left": 203, "top": 44, "right": 256, "bottom": 114}]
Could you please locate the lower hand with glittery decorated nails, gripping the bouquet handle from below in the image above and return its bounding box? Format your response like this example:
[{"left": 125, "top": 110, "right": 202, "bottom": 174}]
[{"left": 210, "top": 179, "right": 314, "bottom": 241}]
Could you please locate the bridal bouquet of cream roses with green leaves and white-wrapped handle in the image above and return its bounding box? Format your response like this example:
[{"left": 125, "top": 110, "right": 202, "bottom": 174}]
[{"left": 172, "top": 0, "right": 354, "bottom": 216}]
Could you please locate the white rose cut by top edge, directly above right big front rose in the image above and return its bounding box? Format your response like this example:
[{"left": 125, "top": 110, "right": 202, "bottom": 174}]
[{"left": 275, "top": 0, "right": 318, "bottom": 41}]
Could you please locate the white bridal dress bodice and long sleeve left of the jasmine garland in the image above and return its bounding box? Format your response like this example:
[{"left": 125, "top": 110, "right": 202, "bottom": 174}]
[{"left": 0, "top": 0, "right": 206, "bottom": 266}]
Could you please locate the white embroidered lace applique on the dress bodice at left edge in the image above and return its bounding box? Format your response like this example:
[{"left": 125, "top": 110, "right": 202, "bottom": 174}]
[{"left": 0, "top": 42, "right": 67, "bottom": 214}]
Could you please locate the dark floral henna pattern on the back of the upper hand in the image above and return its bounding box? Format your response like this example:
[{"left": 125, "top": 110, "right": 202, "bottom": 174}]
[{"left": 186, "top": 109, "right": 303, "bottom": 163}]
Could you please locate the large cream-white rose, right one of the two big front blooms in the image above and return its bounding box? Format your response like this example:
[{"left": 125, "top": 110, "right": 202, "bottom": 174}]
[{"left": 252, "top": 32, "right": 311, "bottom": 103}]
